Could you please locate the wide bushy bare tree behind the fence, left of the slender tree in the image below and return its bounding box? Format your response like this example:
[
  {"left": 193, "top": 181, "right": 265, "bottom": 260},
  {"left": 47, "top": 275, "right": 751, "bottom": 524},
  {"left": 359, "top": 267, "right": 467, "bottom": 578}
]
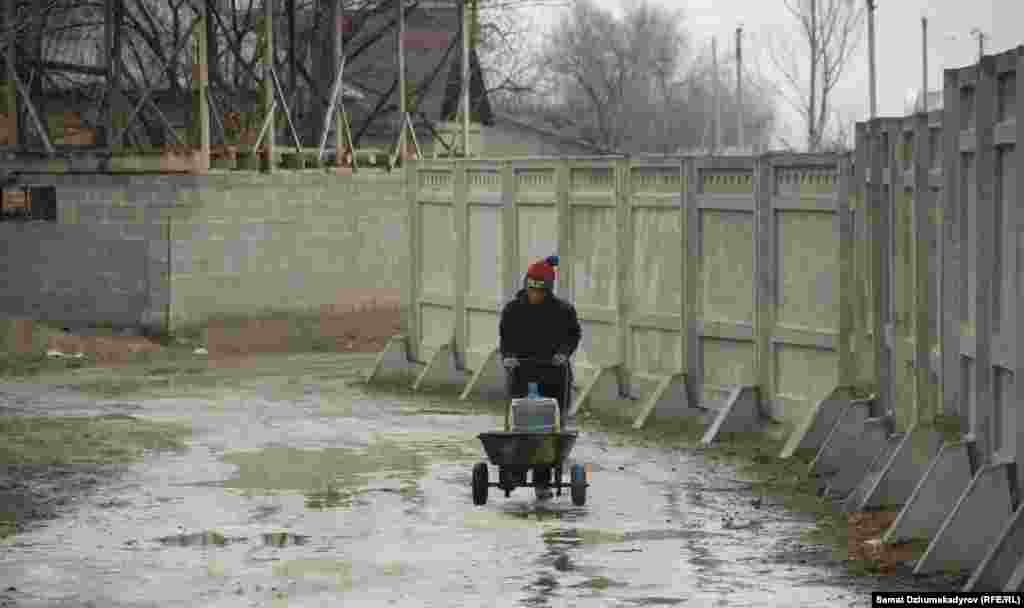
[{"left": 545, "top": 0, "right": 774, "bottom": 154}]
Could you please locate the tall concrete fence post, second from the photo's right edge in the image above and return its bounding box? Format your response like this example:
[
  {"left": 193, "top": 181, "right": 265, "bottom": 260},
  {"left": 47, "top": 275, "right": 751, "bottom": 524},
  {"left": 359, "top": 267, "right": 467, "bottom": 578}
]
[{"left": 970, "top": 55, "right": 999, "bottom": 465}]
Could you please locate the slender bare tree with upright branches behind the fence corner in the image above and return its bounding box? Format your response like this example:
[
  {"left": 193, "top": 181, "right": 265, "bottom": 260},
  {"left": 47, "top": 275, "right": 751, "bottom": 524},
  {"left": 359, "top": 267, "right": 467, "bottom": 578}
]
[{"left": 771, "top": 0, "right": 865, "bottom": 151}]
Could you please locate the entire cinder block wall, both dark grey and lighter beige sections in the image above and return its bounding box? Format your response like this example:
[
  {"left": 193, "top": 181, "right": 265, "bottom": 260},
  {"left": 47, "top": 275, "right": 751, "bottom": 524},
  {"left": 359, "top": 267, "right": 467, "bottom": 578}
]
[{"left": 0, "top": 171, "right": 409, "bottom": 330}]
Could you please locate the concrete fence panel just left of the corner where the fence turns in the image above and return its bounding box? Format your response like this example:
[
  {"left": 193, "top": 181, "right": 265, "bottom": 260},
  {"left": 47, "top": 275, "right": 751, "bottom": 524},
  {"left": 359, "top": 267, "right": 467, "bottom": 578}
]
[{"left": 758, "top": 156, "right": 852, "bottom": 427}]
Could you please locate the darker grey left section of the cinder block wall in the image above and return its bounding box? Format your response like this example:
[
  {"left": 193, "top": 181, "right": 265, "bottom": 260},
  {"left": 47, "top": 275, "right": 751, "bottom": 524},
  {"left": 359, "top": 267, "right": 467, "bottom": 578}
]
[{"left": 0, "top": 175, "right": 178, "bottom": 328}]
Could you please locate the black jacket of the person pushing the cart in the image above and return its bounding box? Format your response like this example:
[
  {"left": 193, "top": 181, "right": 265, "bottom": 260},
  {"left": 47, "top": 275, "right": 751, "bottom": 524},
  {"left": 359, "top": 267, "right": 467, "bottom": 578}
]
[{"left": 498, "top": 290, "right": 583, "bottom": 360}]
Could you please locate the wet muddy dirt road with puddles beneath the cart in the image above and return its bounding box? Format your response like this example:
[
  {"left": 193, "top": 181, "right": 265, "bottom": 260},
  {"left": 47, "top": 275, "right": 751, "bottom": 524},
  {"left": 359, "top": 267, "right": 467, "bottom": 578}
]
[{"left": 0, "top": 356, "right": 942, "bottom": 608}]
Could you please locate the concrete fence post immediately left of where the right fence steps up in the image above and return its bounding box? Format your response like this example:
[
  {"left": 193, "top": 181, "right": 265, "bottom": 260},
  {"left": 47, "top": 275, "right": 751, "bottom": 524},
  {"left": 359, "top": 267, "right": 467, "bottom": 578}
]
[{"left": 912, "top": 112, "right": 937, "bottom": 425}]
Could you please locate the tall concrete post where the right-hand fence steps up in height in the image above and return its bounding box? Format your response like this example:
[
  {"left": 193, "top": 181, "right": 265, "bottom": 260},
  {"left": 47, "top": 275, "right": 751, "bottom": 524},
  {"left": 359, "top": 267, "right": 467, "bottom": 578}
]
[{"left": 939, "top": 70, "right": 962, "bottom": 416}]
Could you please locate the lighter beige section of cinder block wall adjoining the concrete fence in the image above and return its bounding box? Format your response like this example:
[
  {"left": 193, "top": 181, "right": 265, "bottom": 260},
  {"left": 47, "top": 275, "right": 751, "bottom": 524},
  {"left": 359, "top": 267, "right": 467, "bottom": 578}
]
[{"left": 170, "top": 171, "right": 409, "bottom": 328}]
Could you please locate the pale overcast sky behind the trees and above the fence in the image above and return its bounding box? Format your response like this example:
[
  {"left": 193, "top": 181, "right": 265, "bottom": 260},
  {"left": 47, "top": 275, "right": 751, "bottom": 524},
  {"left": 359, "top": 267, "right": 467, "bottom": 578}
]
[{"left": 532, "top": 0, "right": 1024, "bottom": 148}]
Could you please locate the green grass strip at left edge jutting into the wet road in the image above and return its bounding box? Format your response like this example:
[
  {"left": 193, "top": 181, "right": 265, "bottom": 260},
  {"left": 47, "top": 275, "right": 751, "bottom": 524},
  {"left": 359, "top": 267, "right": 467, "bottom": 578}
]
[{"left": 0, "top": 415, "right": 191, "bottom": 465}]
